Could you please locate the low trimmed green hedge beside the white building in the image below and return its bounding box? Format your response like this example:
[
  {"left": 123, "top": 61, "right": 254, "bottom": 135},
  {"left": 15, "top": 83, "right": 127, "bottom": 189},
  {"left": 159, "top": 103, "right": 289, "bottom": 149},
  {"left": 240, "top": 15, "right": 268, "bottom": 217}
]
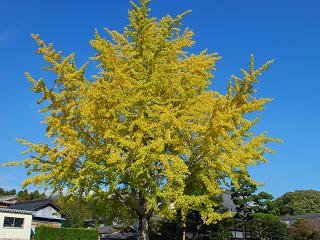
[{"left": 34, "top": 226, "right": 99, "bottom": 240}]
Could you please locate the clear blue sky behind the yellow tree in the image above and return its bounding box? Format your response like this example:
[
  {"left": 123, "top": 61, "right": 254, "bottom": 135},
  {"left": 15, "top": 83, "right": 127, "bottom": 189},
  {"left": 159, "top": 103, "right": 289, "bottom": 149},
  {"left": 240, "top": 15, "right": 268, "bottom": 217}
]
[{"left": 0, "top": 0, "right": 320, "bottom": 196}]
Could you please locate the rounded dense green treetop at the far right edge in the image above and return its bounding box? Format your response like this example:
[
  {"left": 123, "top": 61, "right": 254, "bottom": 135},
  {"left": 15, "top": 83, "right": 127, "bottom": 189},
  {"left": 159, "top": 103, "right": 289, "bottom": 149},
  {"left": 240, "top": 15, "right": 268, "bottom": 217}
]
[{"left": 275, "top": 190, "right": 320, "bottom": 215}]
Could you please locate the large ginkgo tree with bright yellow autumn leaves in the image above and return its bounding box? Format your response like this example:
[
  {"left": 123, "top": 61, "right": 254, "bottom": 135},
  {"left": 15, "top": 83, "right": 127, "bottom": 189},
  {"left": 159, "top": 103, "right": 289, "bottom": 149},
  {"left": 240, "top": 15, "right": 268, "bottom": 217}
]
[{"left": 11, "top": 0, "right": 275, "bottom": 240}]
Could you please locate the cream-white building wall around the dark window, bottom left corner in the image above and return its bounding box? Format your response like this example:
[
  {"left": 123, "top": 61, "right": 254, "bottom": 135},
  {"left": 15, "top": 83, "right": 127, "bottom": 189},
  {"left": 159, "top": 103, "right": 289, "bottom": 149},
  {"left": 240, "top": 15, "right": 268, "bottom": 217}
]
[{"left": 0, "top": 212, "right": 32, "bottom": 240}]
